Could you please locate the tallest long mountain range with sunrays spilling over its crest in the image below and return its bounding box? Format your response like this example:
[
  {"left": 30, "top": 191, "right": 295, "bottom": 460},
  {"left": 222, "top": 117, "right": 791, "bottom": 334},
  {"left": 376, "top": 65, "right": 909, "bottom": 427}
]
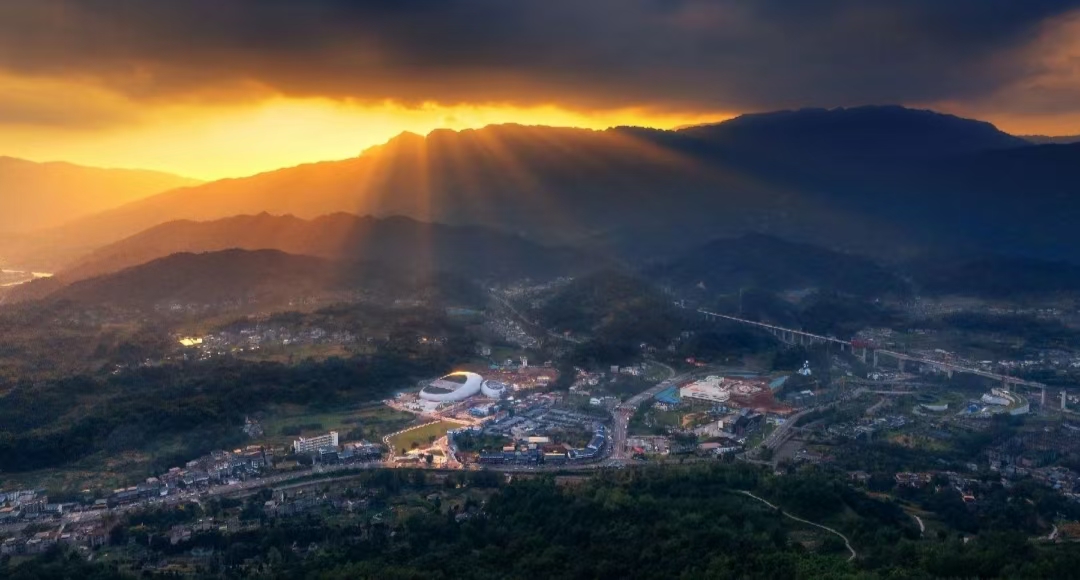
[{"left": 0, "top": 107, "right": 1080, "bottom": 275}]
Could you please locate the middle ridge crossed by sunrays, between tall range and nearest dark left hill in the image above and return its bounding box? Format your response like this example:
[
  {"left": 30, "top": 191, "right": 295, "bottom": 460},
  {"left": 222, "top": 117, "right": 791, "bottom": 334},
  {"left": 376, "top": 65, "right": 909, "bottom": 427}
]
[{"left": 56, "top": 214, "right": 595, "bottom": 283}]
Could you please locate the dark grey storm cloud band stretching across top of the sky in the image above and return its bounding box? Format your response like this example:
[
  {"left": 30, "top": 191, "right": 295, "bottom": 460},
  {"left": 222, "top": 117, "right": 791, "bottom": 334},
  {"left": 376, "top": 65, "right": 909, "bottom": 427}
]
[{"left": 0, "top": 0, "right": 1080, "bottom": 110}]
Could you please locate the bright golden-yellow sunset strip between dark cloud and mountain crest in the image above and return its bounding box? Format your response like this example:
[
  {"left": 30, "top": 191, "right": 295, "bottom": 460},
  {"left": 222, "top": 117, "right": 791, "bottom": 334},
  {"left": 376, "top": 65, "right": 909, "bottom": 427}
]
[{"left": 0, "top": 86, "right": 732, "bottom": 179}]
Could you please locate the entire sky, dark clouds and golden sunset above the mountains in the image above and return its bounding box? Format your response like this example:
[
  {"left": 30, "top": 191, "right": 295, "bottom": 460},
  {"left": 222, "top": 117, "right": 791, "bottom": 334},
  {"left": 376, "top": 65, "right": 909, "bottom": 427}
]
[{"left": 0, "top": 0, "right": 1080, "bottom": 179}]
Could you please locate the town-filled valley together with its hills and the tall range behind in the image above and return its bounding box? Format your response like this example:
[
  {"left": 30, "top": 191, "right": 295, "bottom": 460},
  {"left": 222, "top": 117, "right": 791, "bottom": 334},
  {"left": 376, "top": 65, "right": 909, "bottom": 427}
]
[{"left": 0, "top": 108, "right": 1080, "bottom": 577}]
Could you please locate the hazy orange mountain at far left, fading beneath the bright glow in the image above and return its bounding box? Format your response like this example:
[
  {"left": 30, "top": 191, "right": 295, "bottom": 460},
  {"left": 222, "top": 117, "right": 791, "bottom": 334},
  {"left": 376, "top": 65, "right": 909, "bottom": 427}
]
[{"left": 0, "top": 157, "right": 200, "bottom": 234}]
